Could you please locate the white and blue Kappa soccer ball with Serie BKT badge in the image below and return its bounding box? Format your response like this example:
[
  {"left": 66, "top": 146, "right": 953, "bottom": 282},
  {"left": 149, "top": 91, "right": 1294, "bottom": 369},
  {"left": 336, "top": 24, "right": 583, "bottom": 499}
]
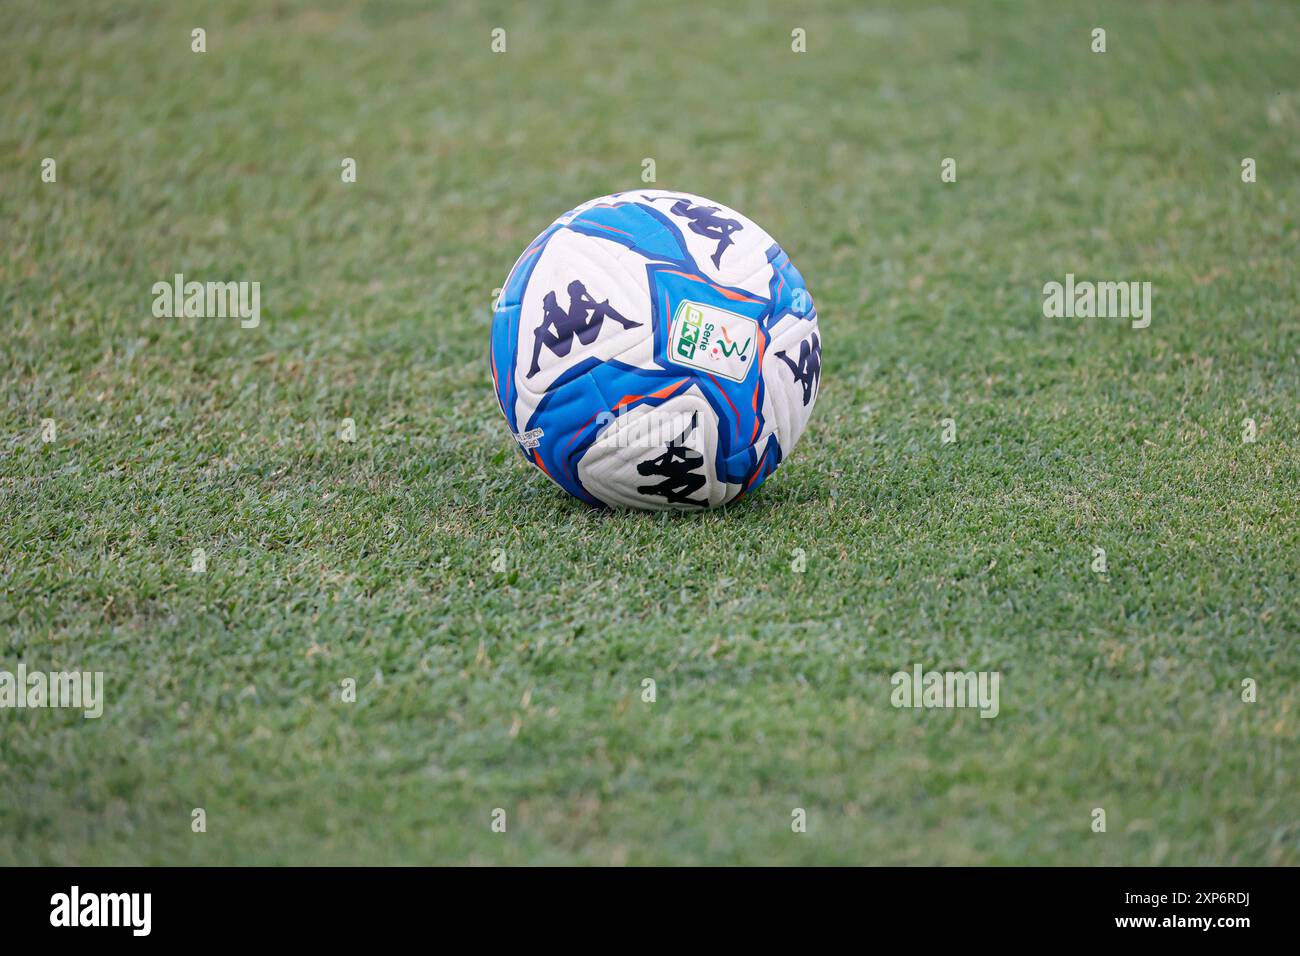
[{"left": 489, "top": 190, "right": 822, "bottom": 510}]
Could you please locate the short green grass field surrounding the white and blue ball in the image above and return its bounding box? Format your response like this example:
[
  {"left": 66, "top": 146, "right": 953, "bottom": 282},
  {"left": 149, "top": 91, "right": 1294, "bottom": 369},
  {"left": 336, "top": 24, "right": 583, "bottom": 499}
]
[{"left": 0, "top": 1, "right": 1300, "bottom": 865}]
